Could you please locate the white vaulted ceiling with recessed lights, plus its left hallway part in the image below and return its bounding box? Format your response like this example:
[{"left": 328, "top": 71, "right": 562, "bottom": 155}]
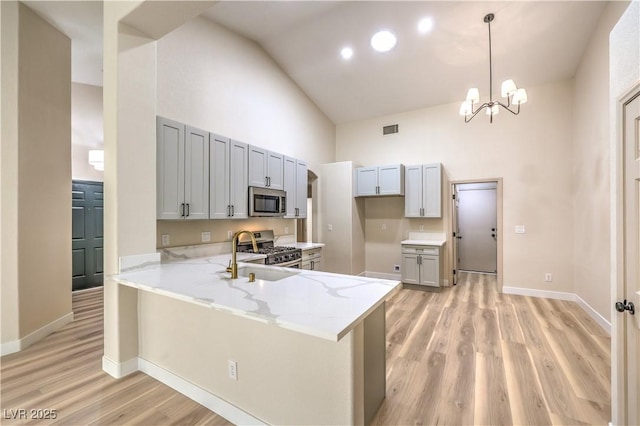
[{"left": 26, "top": 1, "right": 606, "bottom": 123}]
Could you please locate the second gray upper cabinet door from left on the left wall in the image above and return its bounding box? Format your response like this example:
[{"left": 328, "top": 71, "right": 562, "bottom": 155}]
[{"left": 184, "top": 126, "right": 209, "bottom": 220}]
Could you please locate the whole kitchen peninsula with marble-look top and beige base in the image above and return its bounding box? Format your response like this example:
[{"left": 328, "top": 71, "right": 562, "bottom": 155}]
[{"left": 111, "top": 251, "right": 400, "bottom": 424}]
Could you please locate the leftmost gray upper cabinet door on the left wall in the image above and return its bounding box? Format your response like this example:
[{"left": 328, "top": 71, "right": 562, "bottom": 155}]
[{"left": 156, "top": 117, "right": 185, "bottom": 219}]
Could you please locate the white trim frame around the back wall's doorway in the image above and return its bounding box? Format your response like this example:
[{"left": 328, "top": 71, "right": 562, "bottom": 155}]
[{"left": 448, "top": 177, "right": 504, "bottom": 293}]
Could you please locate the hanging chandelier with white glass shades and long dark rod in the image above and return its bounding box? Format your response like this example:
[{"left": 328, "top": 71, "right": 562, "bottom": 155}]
[{"left": 460, "top": 13, "right": 527, "bottom": 123}]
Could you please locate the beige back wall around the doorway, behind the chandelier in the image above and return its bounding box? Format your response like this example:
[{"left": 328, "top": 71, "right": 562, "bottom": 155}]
[{"left": 336, "top": 80, "right": 574, "bottom": 293}]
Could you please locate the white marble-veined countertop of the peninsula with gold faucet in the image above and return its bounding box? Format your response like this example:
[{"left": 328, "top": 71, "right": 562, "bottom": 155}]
[{"left": 111, "top": 254, "right": 401, "bottom": 341}]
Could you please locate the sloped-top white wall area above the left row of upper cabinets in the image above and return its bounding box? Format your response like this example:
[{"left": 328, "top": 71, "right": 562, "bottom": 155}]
[{"left": 157, "top": 18, "right": 335, "bottom": 174}]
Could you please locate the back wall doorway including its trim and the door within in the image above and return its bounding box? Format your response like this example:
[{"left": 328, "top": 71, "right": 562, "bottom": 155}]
[{"left": 451, "top": 179, "right": 502, "bottom": 291}]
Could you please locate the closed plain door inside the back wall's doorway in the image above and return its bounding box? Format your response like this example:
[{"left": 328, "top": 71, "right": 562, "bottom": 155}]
[{"left": 456, "top": 182, "right": 498, "bottom": 273}]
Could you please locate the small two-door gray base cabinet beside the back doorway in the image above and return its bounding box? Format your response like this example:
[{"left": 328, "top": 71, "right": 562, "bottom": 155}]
[{"left": 402, "top": 245, "right": 440, "bottom": 287}]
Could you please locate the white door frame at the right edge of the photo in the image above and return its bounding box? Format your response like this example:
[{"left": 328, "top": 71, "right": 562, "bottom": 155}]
[{"left": 610, "top": 82, "right": 640, "bottom": 424}]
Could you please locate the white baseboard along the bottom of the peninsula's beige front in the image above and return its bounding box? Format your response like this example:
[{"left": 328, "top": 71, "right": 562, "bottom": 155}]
[{"left": 138, "top": 358, "right": 266, "bottom": 425}]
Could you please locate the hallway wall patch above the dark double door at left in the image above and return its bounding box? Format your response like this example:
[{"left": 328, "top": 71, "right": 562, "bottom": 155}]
[{"left": 71, "top": 83, "right": 104, "bottom": 182}]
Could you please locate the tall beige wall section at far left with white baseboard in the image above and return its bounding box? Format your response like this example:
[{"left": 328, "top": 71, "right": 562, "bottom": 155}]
[{"left": 0, "top": 2, "right": 73, "bottom": 353}]
